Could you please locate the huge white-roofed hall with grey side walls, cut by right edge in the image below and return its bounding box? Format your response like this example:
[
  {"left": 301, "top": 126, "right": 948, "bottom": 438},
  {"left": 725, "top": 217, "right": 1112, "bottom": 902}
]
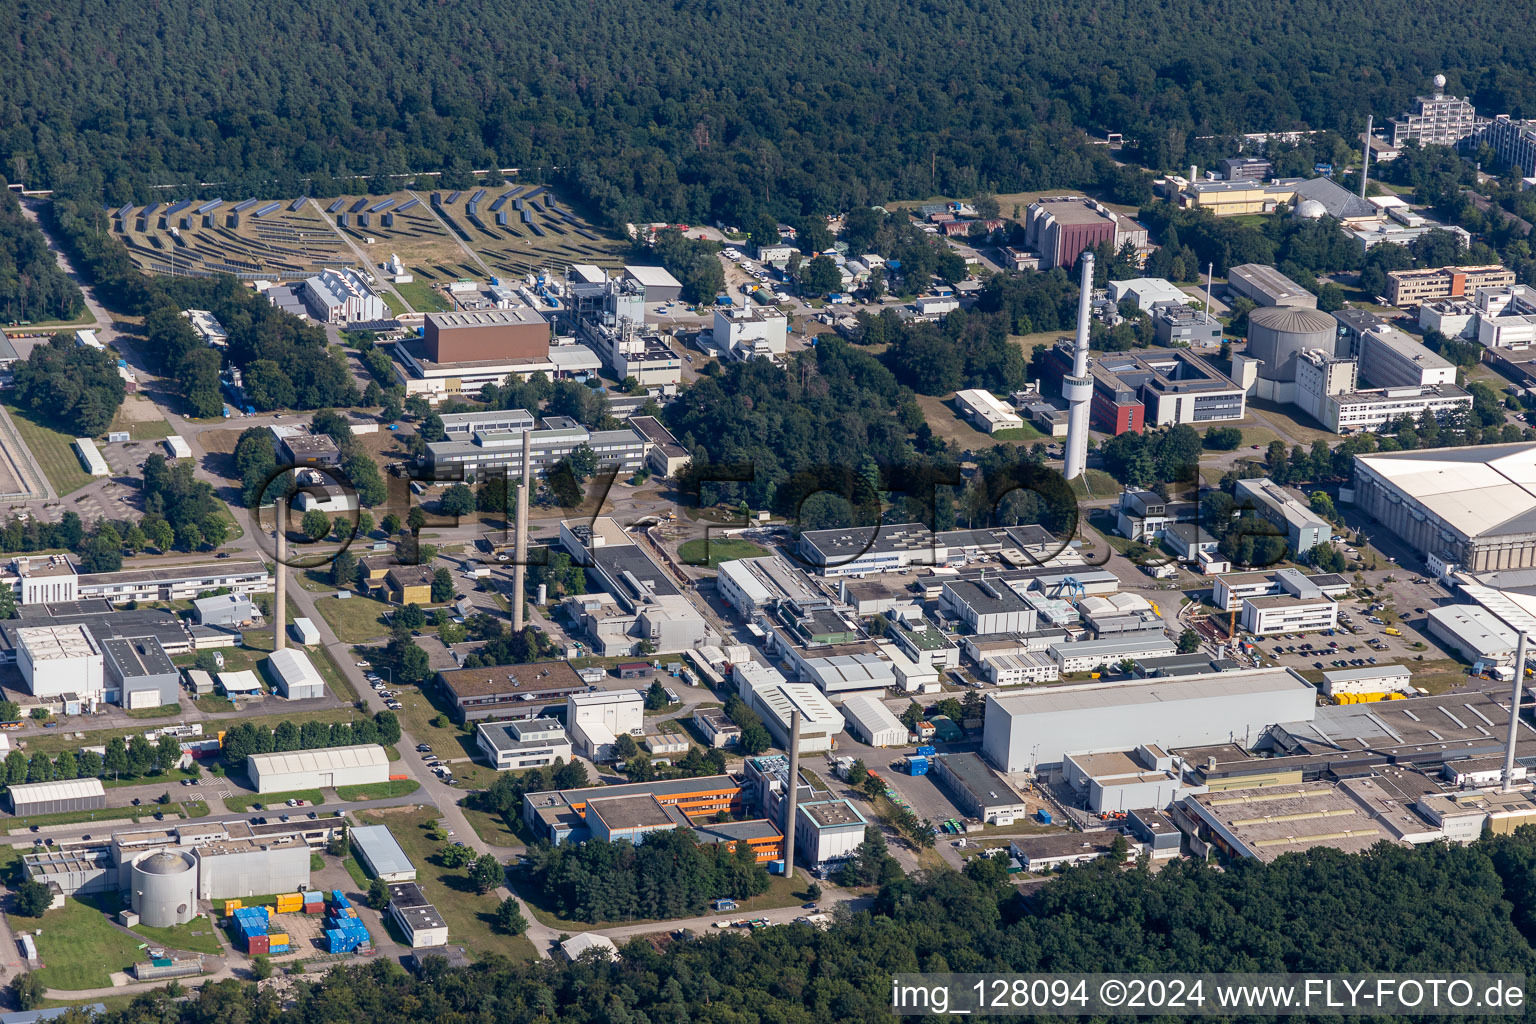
[{"left": 1353, "top": 442, "right": 1536, "bottom": 573}]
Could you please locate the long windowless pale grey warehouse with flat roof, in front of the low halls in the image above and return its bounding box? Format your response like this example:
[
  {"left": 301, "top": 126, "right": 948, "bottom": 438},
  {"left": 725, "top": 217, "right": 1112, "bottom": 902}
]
[{"left": 982, "top": 668, "right": 1318, "bottom": 772}]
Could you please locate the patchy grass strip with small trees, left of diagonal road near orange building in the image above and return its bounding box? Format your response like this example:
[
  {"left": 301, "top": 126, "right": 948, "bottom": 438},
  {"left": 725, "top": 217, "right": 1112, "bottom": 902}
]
[{"left": 356, "top": 808, "right": 536, "bottom": 960}]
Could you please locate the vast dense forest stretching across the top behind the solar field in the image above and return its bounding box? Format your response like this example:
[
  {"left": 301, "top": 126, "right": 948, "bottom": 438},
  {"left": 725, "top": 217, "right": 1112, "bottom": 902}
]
[{"left": 9, "top": 0, "right": 1536, "bottom": 224}]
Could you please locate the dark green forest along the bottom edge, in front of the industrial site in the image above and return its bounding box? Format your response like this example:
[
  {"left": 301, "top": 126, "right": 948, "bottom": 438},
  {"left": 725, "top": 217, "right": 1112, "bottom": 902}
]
[{"left": 48, "top": 829, "right": 1536, "bottom": 1024}]
